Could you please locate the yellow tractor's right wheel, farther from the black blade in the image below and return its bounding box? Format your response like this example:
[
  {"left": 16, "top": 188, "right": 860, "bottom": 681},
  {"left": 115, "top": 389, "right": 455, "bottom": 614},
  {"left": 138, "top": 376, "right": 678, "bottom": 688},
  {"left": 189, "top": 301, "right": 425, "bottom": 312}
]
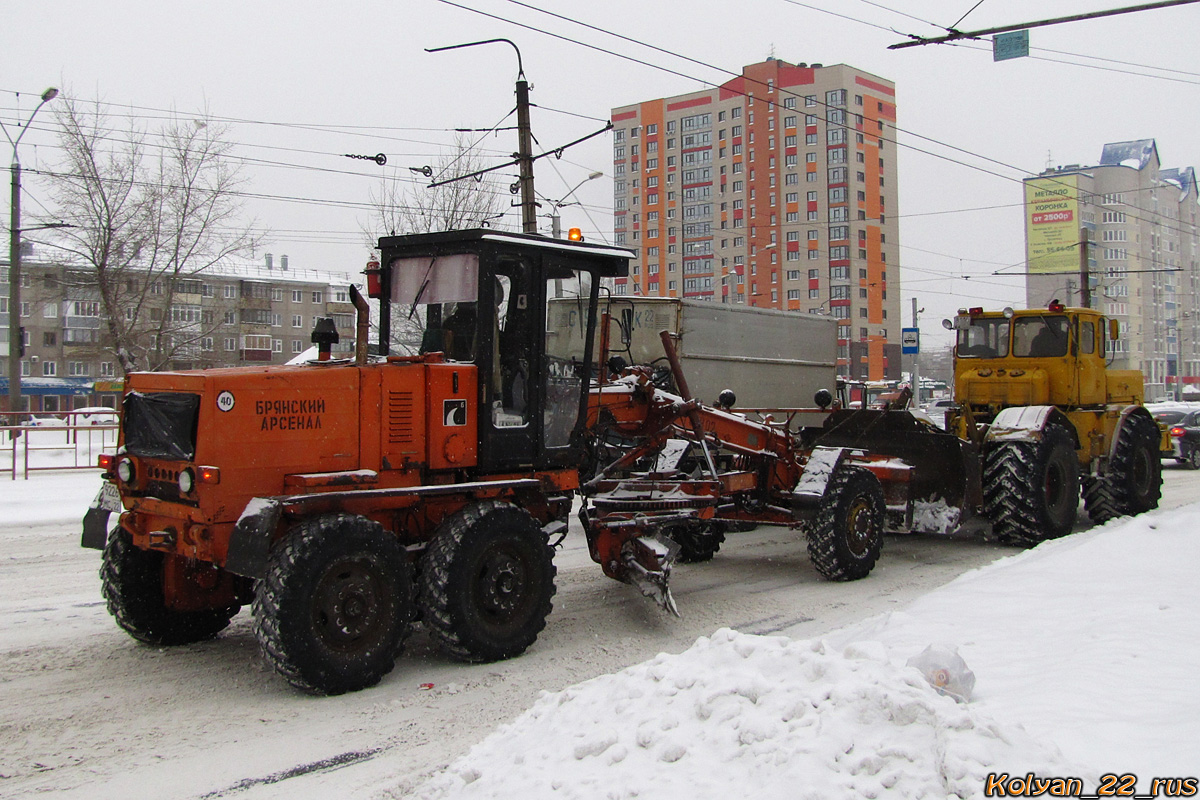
[{"left": 1084, "top": 415, "right": 1163, "bottom": 524}]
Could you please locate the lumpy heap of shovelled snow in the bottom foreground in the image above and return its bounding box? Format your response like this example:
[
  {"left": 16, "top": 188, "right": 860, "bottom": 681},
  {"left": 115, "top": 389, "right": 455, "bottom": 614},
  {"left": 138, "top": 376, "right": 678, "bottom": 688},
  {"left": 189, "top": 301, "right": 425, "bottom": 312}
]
[{"left": 415, "top": 628, "right": 1080, "bottom": 800}]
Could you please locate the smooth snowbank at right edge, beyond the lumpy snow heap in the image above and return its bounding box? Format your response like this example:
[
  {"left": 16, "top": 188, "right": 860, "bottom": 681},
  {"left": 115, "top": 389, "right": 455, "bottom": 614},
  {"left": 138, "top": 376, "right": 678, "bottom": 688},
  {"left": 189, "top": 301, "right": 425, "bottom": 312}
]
[{"left": 828, "top": 505, "right": 1200, "bottom": 777}]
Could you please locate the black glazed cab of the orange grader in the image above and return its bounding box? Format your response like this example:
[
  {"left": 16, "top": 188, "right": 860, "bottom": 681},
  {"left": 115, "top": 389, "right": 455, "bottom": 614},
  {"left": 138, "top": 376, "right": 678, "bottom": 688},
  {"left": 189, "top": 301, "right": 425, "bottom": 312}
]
[{"left": 367, "top": 229, "right": 632, "bottom": 474}]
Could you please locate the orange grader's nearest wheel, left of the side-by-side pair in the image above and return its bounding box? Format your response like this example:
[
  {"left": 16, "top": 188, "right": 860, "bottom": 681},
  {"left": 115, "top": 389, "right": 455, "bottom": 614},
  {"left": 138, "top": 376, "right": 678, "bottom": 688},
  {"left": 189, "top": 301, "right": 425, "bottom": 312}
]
[{"left": 254, "top": 513, "right": 413, "bottom": 694}]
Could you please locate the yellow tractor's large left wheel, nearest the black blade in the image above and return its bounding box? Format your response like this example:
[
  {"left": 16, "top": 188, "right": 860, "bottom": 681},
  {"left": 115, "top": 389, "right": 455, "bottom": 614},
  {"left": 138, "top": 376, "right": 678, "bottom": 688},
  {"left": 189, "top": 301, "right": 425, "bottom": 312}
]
[{"left": 983, "top": 425, "right": 1079, "bottom": 546}]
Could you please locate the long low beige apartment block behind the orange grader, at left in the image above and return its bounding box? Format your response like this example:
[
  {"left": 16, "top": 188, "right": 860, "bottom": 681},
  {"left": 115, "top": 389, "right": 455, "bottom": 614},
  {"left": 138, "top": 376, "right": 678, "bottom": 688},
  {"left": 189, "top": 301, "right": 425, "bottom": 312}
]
[{"left": 0, "top": 245, "right": 355, "bottom": 413}]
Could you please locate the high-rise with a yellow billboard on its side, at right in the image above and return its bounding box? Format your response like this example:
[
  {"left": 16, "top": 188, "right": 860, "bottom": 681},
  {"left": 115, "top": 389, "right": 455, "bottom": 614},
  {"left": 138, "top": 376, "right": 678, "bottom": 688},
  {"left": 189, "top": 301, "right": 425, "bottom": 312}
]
[{"left": 1025, "top": 139, "right": 1200, "bottom": 399}]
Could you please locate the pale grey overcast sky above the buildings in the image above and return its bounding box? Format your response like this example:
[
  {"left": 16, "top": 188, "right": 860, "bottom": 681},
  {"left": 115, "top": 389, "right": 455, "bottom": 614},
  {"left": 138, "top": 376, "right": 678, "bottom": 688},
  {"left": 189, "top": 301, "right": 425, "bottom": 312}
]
[{"left": 7, "top": 0, "right": 1200, "bottom": 343}]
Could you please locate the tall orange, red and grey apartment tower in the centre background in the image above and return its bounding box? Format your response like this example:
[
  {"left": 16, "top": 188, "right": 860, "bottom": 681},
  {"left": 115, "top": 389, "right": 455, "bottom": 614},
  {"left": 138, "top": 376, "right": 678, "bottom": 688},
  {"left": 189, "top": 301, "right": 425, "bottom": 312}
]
[{"left": 612, "top": 59, "right": 902, "bottom": 380}]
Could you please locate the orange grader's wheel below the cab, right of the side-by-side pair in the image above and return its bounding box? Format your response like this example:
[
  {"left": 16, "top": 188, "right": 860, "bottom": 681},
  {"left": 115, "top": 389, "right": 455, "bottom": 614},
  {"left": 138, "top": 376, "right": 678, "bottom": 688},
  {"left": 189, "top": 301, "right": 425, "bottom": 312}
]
[{"left": 420, "top": 501, "right": 556, "bottom": 662}]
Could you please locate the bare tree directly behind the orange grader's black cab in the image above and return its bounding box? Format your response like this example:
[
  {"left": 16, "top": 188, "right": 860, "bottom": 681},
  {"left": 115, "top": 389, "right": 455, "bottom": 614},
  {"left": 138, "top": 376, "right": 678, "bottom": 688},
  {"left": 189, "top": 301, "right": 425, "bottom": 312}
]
[{"left": 362, "top": 136, "right": 511, "bottom": 354}]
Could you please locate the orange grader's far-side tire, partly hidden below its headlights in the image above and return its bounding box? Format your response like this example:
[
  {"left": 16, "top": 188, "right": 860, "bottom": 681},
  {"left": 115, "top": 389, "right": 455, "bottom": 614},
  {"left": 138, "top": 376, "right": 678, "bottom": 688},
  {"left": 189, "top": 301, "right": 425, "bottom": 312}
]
[{"left": 100, "top": 528, "right": 241, "bottom": 646}]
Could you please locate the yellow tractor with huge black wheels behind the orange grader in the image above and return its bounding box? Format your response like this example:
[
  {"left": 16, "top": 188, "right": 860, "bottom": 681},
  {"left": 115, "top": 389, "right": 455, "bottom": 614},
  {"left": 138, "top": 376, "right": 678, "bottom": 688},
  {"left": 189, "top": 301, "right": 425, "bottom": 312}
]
[{"left": 943, "top": 301, "right": 1163, "bottom": 545}]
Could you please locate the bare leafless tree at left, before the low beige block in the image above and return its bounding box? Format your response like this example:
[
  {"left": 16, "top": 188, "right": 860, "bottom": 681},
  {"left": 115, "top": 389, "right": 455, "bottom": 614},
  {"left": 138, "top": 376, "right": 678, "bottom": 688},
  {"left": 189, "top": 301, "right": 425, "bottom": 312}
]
[{"left": 43, "top": 92, "right": 258, "bottom": 374}]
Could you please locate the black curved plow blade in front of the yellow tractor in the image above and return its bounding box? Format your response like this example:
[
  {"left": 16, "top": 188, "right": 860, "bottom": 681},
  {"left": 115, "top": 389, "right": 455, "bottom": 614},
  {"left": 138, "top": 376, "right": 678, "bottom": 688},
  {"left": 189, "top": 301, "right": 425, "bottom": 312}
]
[{"left": 814, "top": 409, "right": 983, "bottom": 533}]
